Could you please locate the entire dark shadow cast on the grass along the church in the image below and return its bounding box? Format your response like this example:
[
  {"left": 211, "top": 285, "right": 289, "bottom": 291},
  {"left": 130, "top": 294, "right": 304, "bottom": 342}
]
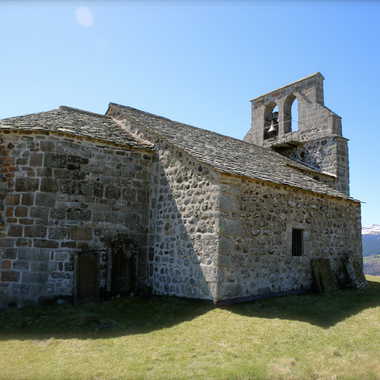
[{"left": 0, "top": 281, "right": 380, "bottom": 340}]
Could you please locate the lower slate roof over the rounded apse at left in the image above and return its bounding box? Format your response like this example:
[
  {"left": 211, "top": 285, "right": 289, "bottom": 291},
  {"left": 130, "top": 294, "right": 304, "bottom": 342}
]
[{"left": 0, "top": 106, "right": 152, "bottom": 149}]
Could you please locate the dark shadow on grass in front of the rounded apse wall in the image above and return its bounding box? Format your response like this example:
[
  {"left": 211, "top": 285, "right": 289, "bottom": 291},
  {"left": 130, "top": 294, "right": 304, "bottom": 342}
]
[{"left": 0, "top": 296, "right": 215, "bottom": 340}]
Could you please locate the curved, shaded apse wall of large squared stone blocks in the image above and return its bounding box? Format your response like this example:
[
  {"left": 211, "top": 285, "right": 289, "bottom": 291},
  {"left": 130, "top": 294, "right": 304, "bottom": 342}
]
[{"left": 0, "top": 133, "right": 152, "bottom": 305}]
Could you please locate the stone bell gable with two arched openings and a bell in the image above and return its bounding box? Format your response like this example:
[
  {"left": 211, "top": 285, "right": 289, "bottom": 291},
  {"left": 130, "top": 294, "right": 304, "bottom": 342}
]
[{"left": 244, "top": 73, "right": 349, "bottom": 195}]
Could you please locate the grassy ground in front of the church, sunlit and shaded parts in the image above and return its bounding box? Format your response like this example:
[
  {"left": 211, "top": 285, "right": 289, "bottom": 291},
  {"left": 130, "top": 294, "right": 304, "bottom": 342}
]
[{"left": 0, "top": 276, "right": 380, "bottom": 380}]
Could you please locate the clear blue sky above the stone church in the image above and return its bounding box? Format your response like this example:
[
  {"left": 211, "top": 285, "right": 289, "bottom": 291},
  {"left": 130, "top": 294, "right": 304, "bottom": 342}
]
[{"left": 0, "top": 0, "right": 380, "bottom": 225}]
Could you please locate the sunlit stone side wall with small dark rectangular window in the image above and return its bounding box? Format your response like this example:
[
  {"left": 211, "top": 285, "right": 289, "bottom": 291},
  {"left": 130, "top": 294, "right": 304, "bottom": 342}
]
[{"left": 218, "top": 176, "right": 362, "bottom": 300}]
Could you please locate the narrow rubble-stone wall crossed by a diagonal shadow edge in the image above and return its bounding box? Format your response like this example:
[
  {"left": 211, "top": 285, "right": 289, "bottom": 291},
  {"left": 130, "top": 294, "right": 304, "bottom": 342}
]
[{"left": 150, "top": 139, "right": 219, "bottom": 300}]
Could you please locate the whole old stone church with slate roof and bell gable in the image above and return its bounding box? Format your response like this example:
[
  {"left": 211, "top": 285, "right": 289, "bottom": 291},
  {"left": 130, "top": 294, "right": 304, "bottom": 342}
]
[{"left": 0, "top": 73, "right": 365, "bottom": 306}]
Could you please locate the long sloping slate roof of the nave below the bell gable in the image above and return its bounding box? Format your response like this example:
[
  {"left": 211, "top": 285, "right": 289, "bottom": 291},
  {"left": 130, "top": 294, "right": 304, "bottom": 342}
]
[{"left": 106, "top": 103, "right": 353, "bottom": 200}]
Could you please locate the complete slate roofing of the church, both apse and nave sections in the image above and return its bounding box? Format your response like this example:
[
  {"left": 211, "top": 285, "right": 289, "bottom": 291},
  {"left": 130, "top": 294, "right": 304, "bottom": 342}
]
[{"left": 0, "top": 103, "right": 354, "bottom": 200}]
